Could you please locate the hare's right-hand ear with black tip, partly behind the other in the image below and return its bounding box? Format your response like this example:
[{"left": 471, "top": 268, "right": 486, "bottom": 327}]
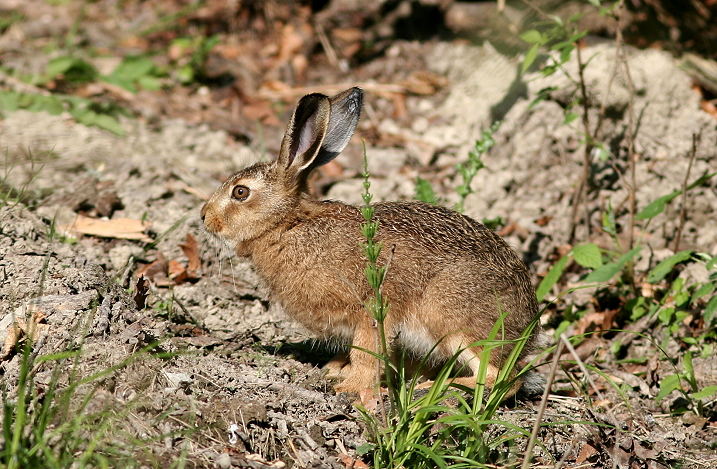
[{"left": 310, "top": 87, "right": 363, "bottom": 168}]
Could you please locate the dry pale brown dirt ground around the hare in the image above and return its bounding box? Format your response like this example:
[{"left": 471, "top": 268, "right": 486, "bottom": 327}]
[{"left": 0, "top": 2, "right": 717, "bottom": 468}]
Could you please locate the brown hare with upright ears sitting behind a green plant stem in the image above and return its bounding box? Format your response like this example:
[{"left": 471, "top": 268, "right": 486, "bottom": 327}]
[{"left": 201, "top": 88, "right": 538, "bottom": 394}]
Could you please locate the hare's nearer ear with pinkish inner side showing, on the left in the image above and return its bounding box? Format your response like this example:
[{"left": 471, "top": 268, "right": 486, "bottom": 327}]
[{"left": 277, "top": 93, "right": 331, "bottom": 171}]
